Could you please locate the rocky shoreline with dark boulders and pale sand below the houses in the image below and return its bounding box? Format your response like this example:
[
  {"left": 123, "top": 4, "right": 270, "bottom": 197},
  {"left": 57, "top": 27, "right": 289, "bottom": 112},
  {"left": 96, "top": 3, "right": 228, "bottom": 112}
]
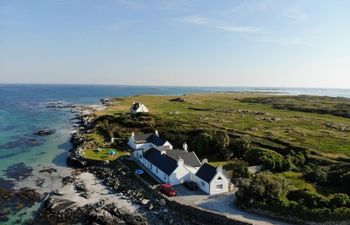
[{"left": 30, "top": 101, "right": 211, "bottom": 225}]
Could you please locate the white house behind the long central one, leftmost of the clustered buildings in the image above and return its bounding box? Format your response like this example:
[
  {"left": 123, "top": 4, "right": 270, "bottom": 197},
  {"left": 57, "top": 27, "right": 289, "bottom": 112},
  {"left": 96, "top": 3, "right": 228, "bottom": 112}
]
[{"left": 128, "top": 130, "right": 173, "bottom": 159}]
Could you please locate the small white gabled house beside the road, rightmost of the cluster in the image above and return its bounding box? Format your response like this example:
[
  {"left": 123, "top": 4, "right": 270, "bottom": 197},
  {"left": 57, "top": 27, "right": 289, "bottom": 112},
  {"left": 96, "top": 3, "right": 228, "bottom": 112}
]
[{"left": 195, "top": 162, "right": 230, "bottom": 195}]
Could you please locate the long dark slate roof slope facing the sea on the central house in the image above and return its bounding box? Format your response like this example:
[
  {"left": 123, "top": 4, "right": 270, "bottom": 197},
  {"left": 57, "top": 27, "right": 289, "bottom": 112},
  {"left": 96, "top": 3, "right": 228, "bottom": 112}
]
[{"left": 143, "top": 148, "right": 177, "bottom": 176}]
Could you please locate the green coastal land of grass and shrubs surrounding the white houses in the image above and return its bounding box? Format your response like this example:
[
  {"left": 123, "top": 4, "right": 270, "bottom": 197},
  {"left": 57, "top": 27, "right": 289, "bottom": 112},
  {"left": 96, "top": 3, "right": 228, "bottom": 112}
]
[{"left": 58, "top": 93, "right": 350, "bottom": 224}]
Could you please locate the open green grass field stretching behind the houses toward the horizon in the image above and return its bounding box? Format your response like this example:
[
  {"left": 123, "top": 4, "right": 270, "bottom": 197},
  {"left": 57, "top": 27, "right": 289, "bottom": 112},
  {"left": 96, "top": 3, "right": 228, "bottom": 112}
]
[{"left": 98, "top": 93, "right": 350, "bottom": 157}]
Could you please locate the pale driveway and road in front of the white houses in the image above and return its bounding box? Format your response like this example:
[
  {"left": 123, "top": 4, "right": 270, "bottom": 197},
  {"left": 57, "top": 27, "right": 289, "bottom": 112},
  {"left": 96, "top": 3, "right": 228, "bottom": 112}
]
[{"left": 173, "top": 185, "right": 291, "bottom": 225}]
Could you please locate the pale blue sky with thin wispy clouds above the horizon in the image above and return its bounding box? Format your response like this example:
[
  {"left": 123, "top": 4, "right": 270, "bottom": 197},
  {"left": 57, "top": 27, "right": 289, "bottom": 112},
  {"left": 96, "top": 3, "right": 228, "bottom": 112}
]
[{"left": 0, "top": 0, "right": 350, "bottom": 88}]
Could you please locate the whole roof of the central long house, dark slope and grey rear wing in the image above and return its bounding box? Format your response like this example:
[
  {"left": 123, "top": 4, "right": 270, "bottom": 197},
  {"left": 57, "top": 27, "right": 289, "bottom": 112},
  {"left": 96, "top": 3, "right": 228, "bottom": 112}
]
[{"left": 143, "top": 148, "right": 201, "bottom": 175}]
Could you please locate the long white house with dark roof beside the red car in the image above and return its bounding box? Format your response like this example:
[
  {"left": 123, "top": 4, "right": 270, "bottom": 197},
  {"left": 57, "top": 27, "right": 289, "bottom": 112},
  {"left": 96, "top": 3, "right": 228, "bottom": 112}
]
[{"left": 139, "top": 147, "right": 201, "bottom": 185}]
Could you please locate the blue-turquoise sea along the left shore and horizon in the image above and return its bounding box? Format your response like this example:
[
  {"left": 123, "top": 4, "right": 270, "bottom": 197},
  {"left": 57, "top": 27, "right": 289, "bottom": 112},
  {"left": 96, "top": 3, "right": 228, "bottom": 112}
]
[{"left": 0, "top": 84, "right": 350, "bottom": 225}]
